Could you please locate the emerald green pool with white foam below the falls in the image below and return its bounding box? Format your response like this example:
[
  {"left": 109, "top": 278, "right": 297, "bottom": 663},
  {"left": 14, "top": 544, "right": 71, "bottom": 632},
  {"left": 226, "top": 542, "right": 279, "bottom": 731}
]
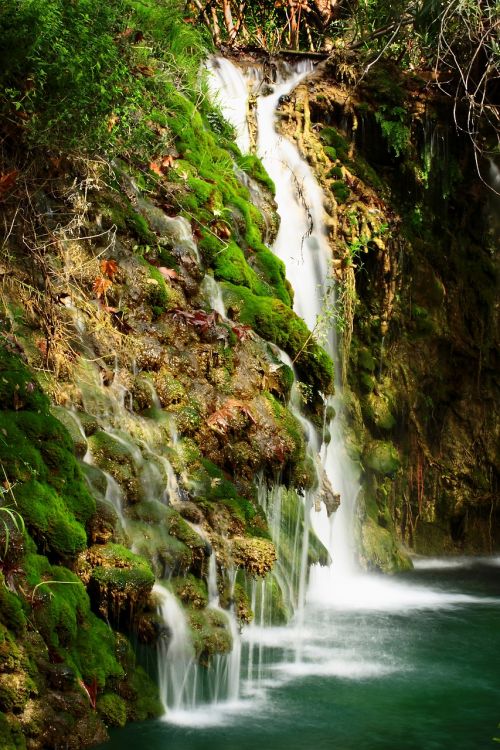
[{"left": 99, "top": 558, "right": 500, "bottom": 750}]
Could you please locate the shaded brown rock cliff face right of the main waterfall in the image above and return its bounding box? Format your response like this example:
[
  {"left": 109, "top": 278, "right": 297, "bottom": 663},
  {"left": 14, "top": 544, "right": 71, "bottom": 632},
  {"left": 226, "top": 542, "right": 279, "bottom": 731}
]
[{"left": 282, "top": 59, "right": 500, "bottom": 569}]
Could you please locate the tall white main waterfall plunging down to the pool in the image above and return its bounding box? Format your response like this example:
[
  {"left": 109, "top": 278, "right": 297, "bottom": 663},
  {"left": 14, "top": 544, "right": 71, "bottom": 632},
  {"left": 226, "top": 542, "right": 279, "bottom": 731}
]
[{"left": 211, "top": 60, "right": 360, "bottom": 610}]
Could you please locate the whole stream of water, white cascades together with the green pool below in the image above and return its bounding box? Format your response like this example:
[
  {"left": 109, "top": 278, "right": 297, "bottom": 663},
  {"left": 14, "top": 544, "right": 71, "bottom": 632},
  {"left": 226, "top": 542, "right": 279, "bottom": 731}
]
[{"left": 94, "top": 60, "right": 500, "bottom": 750}]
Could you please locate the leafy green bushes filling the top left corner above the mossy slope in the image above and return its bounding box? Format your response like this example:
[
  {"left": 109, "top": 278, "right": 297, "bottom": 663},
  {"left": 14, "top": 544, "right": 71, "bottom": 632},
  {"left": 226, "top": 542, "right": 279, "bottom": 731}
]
[{"left": 0, "top": 0, "right": 209, "bottom": 155}]
